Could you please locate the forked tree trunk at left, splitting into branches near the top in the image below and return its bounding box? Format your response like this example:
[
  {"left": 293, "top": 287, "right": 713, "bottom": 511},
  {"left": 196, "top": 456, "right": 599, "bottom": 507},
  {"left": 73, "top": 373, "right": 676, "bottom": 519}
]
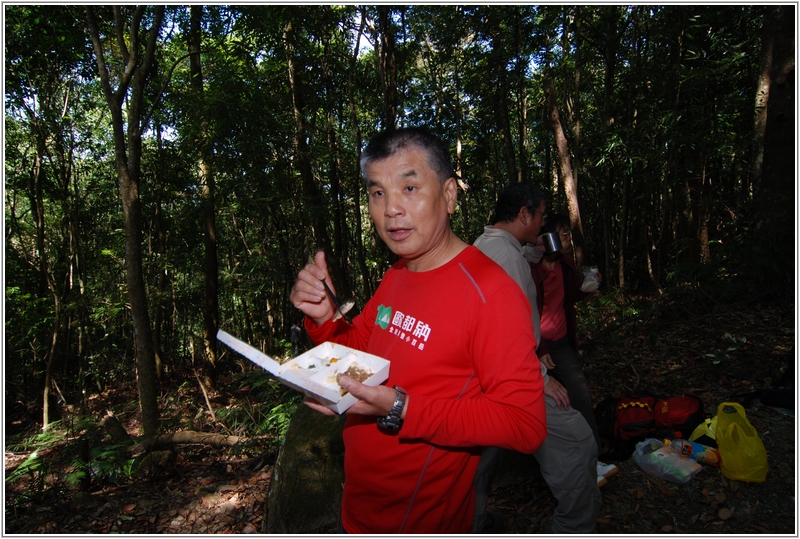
[{"left": 86, "top": 6, "right": 164, "bottom": 436}]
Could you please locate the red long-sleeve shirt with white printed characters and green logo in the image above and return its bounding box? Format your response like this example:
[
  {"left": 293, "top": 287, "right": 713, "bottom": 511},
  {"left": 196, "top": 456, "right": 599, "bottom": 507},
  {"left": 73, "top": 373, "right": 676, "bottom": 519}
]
[{"left": 306, "top": 246, "right": 547, "bottom": 534}]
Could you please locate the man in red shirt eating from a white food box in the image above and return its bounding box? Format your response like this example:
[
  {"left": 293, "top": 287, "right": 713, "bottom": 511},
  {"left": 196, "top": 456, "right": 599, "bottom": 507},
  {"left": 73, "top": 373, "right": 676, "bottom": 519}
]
[{"left": 290, "top": 128, "right": 546, "bottom": 534}]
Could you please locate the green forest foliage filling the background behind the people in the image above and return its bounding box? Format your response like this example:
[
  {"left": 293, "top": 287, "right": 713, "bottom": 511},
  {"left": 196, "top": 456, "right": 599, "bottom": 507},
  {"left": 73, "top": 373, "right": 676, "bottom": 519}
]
[{"left": 4, "top": 5, "right": 795, "bottom": 440}]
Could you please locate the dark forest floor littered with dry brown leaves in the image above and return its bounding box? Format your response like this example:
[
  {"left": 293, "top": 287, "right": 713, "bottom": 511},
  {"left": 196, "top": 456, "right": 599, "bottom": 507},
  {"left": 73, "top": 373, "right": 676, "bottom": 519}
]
[{"left": 4, "top": 288, "right": 798, "bottom": 535}]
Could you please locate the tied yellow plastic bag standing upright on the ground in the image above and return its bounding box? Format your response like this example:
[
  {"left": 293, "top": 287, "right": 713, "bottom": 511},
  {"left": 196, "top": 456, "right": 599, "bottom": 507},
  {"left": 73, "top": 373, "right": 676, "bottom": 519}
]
[{"left": 715, "top": 402, "right": 768, "bottom": 483}]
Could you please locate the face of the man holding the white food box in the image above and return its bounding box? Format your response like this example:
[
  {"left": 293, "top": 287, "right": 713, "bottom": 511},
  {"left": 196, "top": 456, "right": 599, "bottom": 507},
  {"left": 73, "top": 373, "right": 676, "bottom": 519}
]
[{"left": 366, "top": 147, "right": 457, "bottom": 266}]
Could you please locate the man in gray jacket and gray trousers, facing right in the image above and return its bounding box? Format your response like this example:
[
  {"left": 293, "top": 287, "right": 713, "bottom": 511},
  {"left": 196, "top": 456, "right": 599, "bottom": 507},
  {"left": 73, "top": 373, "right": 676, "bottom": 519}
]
[{"left": 473, "top": 183, "right": 602, "bottom": 534}]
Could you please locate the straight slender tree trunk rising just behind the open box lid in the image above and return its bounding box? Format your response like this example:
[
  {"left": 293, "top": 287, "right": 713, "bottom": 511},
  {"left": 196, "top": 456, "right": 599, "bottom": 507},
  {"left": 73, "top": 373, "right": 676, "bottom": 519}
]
[{"left": 188, "top": 5, "right": 219, "bottom": 389}]
